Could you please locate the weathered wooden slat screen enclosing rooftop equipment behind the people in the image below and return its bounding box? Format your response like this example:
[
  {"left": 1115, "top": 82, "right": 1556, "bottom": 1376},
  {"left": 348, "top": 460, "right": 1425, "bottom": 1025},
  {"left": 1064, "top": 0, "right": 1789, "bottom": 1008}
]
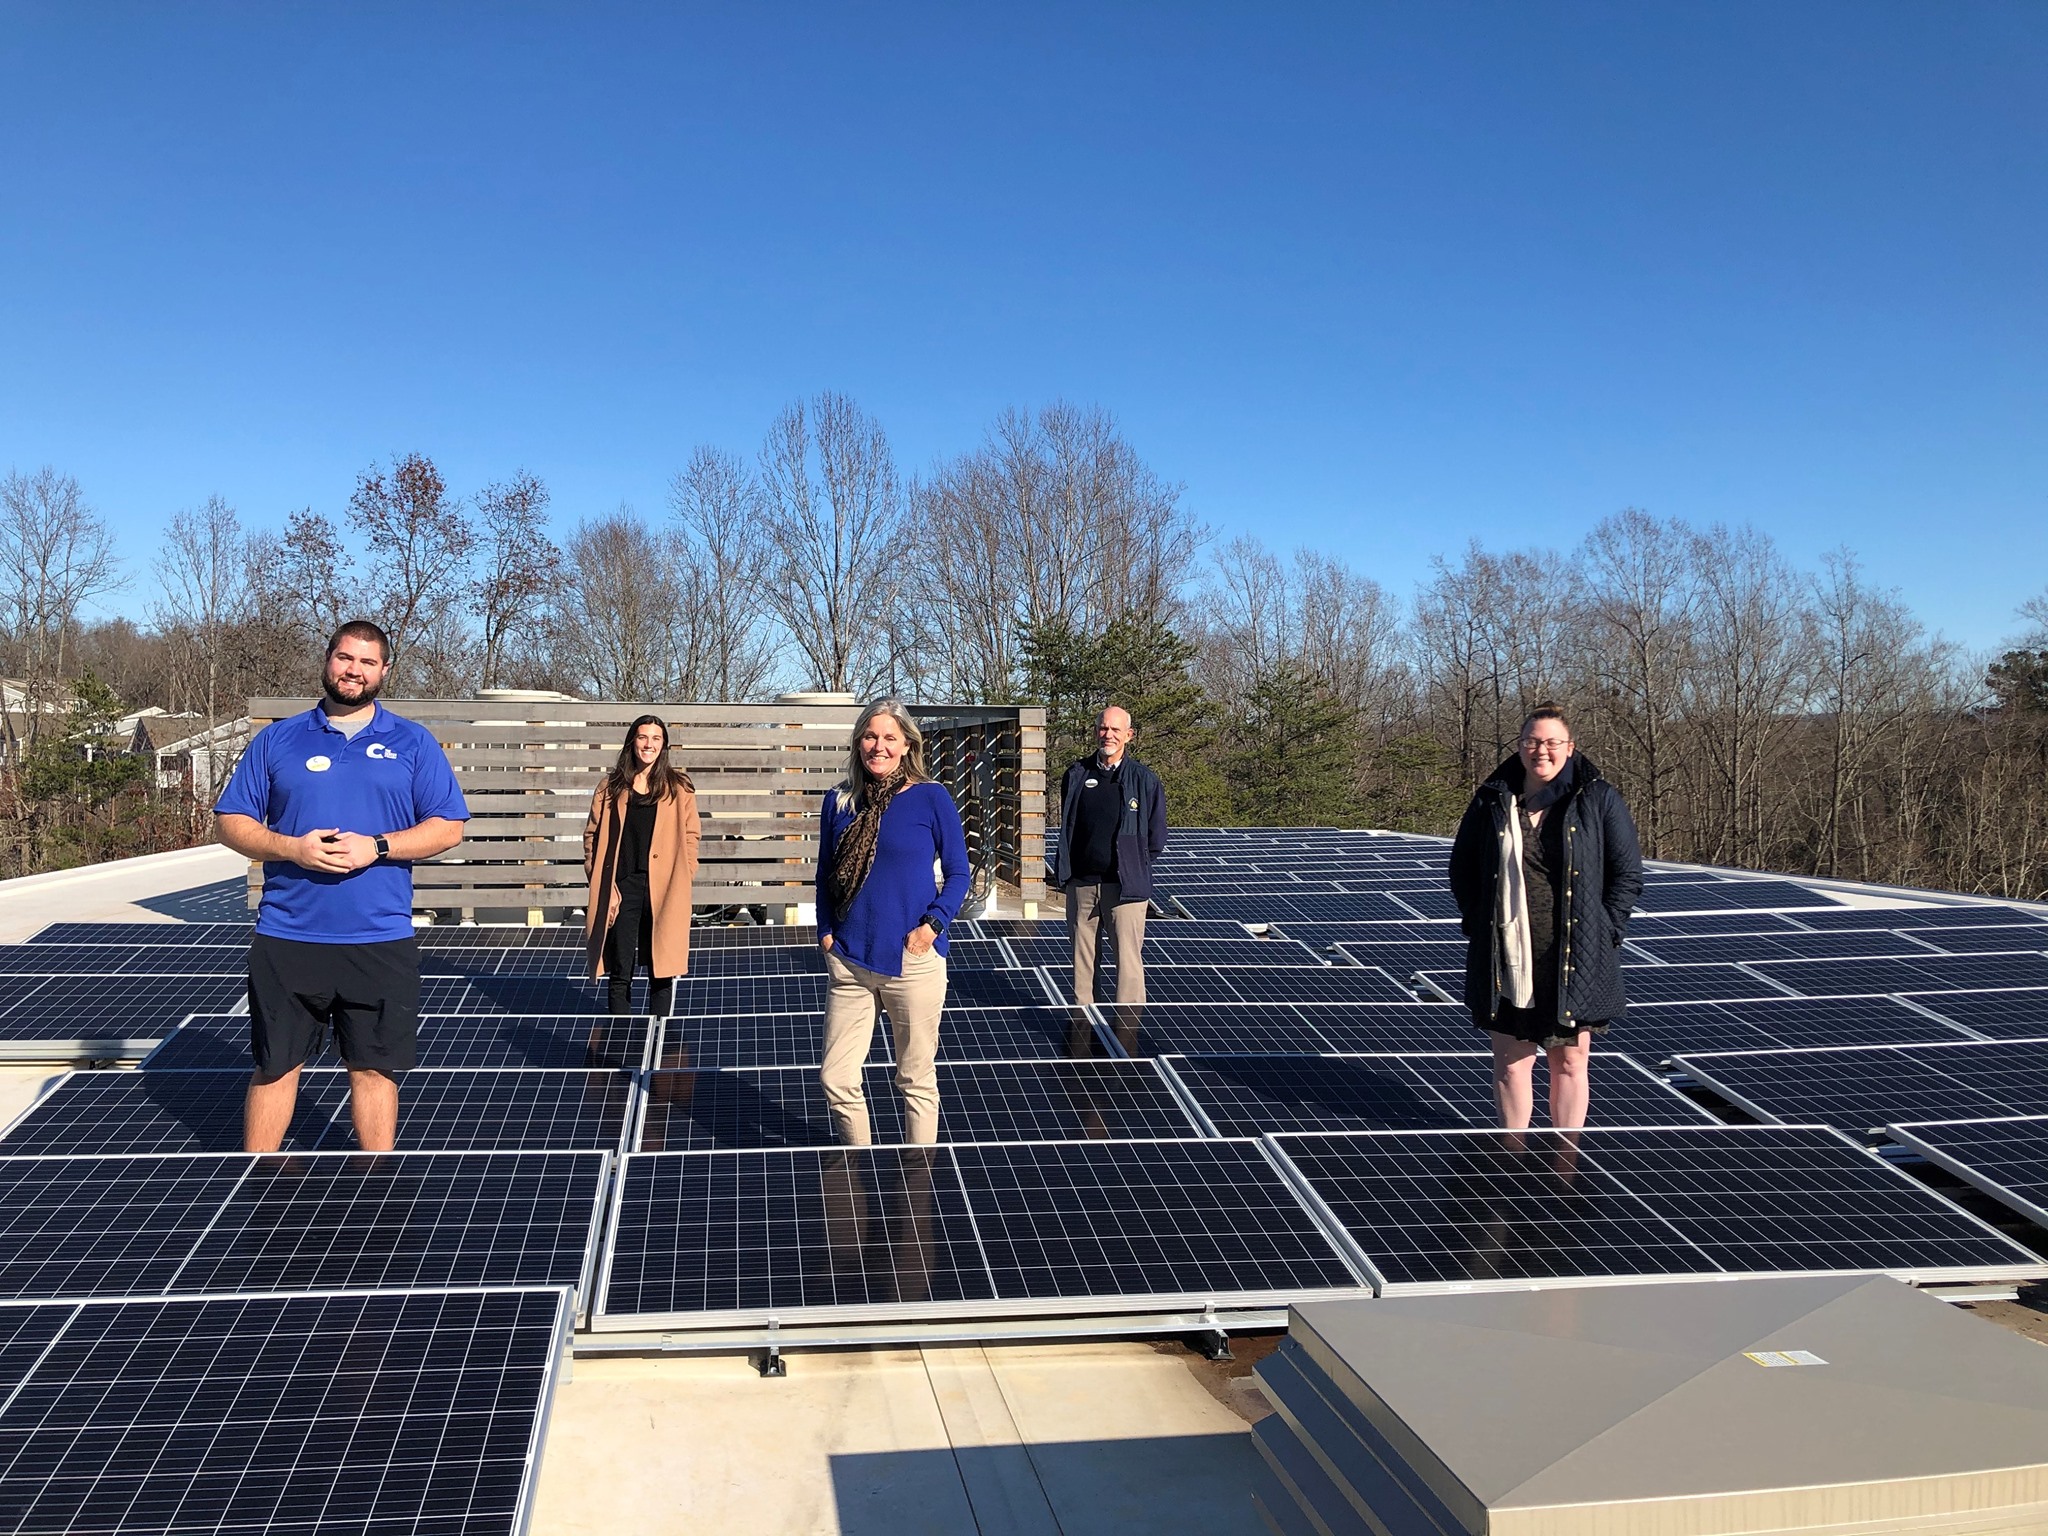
[{"left": 250, "top": 698, "right": 1044, "bottom": 922}]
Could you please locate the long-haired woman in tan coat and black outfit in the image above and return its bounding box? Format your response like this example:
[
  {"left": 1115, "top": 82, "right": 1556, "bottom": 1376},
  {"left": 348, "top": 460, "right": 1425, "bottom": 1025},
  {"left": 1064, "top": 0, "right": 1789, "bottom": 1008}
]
[{"left": 584, "top": 715, "right": 700, "bottom": 1014}]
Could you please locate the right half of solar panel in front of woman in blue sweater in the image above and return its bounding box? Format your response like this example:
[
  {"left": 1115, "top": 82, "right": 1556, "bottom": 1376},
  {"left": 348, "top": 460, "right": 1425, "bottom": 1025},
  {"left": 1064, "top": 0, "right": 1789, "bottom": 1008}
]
[{"left": 954, "top": 1141, "right": 1358, "bottom": 1300}]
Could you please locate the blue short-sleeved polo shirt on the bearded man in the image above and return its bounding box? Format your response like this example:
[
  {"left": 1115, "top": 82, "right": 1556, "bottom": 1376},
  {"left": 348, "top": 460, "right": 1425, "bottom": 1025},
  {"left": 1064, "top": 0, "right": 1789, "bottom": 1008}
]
[{"left": 213, "top": 705, "right": 469, "bottom": 944}]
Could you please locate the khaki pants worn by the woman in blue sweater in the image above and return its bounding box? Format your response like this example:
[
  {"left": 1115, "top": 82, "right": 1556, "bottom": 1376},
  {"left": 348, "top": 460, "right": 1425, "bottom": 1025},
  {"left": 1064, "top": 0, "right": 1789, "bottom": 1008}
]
[{"left": 819, "top": 950, "right": 946, "bottom": 1147}]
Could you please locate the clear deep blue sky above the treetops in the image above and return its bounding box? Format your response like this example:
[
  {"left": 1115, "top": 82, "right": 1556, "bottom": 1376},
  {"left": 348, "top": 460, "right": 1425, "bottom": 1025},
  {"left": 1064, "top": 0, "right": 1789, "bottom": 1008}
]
[{"left": 0, "top": 0, "right": 2048, "bottom": 645}]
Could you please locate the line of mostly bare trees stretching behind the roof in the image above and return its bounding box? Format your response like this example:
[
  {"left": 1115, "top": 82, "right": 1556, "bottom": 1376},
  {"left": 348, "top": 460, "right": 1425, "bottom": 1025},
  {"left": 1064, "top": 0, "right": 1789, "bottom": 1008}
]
[{"left": 0, "top": 393, "right": 2048, "bottom": 897}]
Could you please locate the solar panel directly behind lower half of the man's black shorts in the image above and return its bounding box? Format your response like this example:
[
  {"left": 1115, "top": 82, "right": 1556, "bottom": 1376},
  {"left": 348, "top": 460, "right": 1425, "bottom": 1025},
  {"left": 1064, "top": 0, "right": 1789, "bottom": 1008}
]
[{"left": 141, "top": 1014, "right": 653, "bottom": 1071}]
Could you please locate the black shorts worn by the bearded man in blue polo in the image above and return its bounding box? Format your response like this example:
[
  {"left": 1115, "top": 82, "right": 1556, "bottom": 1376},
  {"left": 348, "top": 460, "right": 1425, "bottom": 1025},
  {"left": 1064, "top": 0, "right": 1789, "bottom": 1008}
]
[{"left": 250, "top": 934, "right": 420, "bottom": 1083}]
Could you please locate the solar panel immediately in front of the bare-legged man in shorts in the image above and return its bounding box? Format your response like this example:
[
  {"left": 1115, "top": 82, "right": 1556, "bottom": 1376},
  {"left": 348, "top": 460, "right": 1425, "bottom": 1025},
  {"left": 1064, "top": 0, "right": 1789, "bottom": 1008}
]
[{"left": 0, "top": 1151, "right": 608, "bottom": 1298}]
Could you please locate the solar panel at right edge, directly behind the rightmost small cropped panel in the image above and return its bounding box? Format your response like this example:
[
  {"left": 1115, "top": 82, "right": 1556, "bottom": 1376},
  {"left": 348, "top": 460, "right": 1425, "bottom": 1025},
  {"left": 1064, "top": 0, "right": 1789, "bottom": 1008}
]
[{"left": 1677, "top": 1040, "right": 2048, "bottom": 1133}]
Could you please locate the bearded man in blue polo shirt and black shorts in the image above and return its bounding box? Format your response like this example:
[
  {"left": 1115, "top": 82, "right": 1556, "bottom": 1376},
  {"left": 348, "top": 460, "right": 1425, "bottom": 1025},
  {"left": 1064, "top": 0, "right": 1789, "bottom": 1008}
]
[{"left": 213, "top": 618, "right": 469, "bottom": 1151}]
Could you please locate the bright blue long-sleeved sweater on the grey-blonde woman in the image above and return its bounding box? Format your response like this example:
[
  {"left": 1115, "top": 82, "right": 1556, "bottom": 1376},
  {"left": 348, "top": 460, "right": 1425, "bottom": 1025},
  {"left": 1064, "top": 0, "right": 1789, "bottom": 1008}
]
[{"left": 817, "top": 780, "right": 967, "bottom": 977}]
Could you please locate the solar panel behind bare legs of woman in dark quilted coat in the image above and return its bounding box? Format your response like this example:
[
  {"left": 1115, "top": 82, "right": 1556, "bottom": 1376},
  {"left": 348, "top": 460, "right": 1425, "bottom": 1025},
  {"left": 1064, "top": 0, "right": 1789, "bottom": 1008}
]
[{"left": 1169, "top": 1051, "right": 1712, "bottom": 1137}]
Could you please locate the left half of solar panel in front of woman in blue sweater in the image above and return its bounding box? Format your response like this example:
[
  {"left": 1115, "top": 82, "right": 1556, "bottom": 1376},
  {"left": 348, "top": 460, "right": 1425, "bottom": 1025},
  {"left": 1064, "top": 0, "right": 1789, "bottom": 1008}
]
[{"left": 602, "top": 1147, "right": 995, "bottom": 1319}]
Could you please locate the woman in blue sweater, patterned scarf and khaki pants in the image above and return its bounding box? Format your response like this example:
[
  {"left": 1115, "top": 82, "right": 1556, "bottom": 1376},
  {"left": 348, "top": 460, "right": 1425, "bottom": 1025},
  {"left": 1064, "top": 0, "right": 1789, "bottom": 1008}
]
[{"left": 817, "top": 698, "right": 967, "bottom": 1147}]
